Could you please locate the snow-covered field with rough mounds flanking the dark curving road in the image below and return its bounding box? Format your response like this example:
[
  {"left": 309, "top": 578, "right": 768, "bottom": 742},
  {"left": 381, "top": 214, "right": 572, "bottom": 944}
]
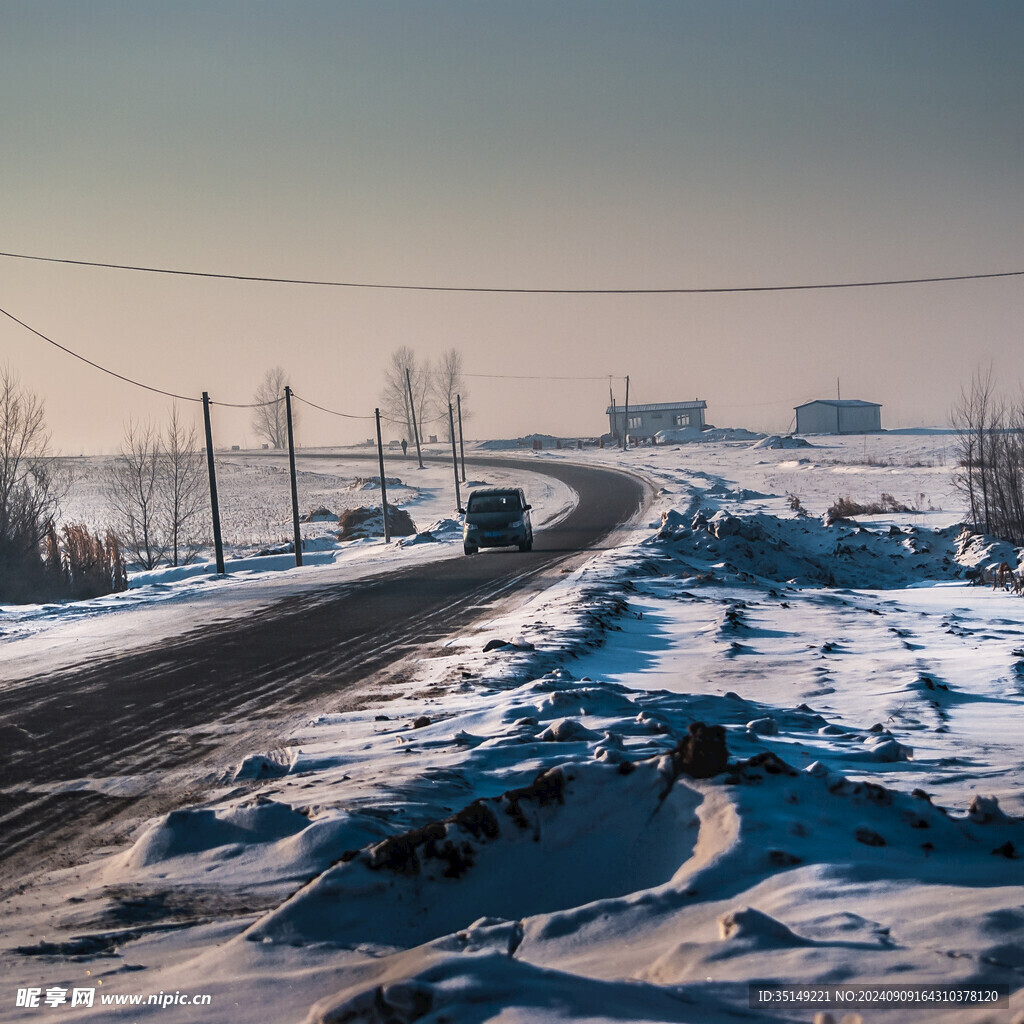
[{"left": 0, "top": 433, "right": 1024, "bottom": 1024}]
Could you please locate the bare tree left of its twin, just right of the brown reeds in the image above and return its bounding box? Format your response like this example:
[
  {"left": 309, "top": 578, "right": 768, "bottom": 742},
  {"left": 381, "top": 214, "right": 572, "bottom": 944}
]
[{"left": 111, "top": 421, "right": 168, "bottom": 569}]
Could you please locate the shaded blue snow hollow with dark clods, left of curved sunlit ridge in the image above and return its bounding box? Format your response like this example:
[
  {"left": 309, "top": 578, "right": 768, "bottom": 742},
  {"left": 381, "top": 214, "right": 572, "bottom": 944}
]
[{"left": 247, "top": 760, "right": 700, "bottom": 947}]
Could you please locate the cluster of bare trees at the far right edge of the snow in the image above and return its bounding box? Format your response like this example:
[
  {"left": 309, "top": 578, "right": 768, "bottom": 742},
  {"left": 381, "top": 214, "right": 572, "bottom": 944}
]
[{"left": 952, "top": 370, "right": 1024, "bottom": 546}]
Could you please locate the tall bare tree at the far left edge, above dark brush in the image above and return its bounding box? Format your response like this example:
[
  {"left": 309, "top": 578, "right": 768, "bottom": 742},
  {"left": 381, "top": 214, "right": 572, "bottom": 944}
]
[{"left": 0, "top": 367, "right": 61, "bottom": 600}]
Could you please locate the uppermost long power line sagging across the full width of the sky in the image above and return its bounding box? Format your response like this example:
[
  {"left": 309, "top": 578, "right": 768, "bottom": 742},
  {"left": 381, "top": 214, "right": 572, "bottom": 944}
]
[{"left": 0, "top": 253, "right": 1024, "bottom": 295}]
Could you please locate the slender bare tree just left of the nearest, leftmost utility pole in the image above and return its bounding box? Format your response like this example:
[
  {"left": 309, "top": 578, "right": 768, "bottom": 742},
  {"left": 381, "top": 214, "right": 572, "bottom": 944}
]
[{"left": 158, "top": 404, "right": 209, "bottom": 565}]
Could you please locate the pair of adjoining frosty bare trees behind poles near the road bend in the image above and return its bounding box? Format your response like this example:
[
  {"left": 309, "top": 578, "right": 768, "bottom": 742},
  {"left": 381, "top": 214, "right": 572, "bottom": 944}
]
[{"left": 381, "top": 345, "right": 469, "bottom": 440}]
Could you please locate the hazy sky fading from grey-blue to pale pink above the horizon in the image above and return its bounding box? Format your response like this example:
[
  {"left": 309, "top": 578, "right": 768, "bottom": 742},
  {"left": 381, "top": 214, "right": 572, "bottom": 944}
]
[{"left": 0, "top": 0, "right": 1024, "bottom": 454}]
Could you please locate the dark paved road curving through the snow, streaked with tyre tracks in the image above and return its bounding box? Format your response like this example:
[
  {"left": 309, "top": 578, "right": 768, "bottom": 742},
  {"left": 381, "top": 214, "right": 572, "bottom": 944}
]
[{"left": 0, "top": 457, "right": 643, "bottom": 880}]
